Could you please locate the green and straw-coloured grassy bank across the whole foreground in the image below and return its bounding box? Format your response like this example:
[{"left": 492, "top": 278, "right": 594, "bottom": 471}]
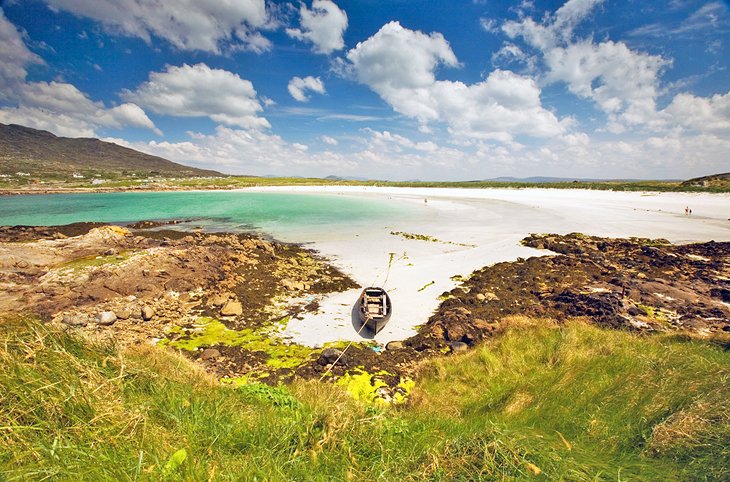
[{"left": 0, "top": 319, "right": 730, "bottom": 480}]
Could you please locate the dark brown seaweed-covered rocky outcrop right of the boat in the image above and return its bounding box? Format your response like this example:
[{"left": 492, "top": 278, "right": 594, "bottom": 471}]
[{"left": 414, "top": 233, "right": 730, "bottom": 345}]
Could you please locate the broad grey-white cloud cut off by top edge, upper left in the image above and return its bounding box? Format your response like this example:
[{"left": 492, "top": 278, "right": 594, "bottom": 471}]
[{"left": 40, "top": 0, "right": 271, "bottom": 53}]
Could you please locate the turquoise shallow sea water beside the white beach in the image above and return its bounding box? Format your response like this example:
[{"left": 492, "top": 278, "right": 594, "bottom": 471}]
[{"left": 0, "top": 191, "right": 412, "bottom": 239}]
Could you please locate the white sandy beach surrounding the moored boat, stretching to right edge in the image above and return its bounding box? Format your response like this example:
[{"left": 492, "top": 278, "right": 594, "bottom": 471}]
[{"left": 245, "top": 186, "right": 730, "bottom": 346}]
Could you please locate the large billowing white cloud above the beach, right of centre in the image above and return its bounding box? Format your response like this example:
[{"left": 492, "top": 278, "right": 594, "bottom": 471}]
[{"left": 346, "top": 22, "right": 569, "bottom": 142}]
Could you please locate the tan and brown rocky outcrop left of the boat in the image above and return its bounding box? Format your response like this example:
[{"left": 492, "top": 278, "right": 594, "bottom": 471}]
[{"left": 0, "top": 222, "right": 357, "bottom": 381}]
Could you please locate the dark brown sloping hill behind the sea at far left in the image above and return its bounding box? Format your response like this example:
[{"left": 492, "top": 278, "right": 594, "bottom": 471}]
[{"left": 0, "top": 124, "right": 223, "bottom": 178}]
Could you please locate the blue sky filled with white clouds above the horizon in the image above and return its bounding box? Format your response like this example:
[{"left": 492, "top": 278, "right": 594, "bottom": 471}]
[{"left": 0, "top": 0, "right": 730, "bottom": 180}]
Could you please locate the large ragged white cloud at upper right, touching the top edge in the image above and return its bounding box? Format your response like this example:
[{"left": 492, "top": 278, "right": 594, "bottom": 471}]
[{"left": 502, "top": 0, "right": 671, "bottom": 132}]
